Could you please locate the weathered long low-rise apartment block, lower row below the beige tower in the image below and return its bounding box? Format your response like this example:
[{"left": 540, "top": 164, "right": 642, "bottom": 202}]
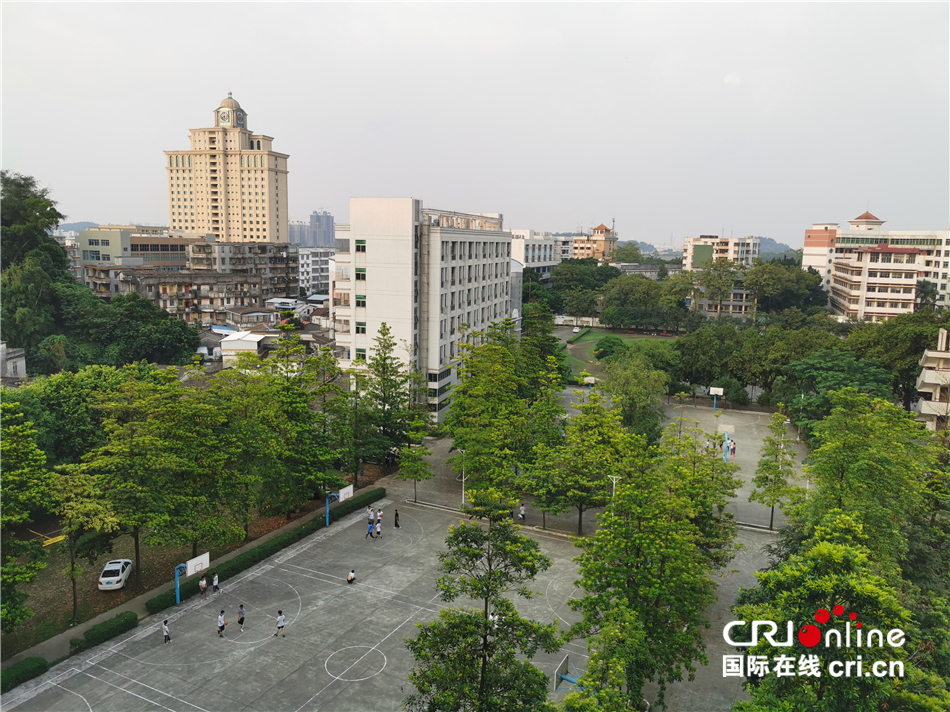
[{"left": 117, "top": 268, "right": 264, "bottom": 325}]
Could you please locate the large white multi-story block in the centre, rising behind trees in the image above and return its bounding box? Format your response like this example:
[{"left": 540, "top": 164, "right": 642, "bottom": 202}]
[{"left": 331, "top": 198, "right": 512, "bottom": 420}]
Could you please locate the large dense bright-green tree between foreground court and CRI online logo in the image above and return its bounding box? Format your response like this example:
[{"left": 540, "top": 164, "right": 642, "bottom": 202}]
[{"left": 569, "top": 462, "right": 715, "bottom": 704}]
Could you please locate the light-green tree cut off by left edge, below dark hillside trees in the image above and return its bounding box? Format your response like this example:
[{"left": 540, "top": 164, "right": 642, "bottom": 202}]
[{"left": 0, "top": 394, "right": 52, "bottom": 633}]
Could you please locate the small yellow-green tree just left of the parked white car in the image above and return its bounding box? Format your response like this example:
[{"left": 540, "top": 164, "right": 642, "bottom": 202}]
[{"left": 51, "top": 465, "right": 119, "bottom": 623}]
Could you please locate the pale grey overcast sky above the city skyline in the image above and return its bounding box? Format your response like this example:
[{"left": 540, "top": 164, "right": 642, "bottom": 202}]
[{"left": 2, "top": 2, "right": 950, "bottom": 246}]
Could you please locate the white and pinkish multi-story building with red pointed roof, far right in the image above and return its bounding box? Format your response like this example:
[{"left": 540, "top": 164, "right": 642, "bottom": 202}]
[{"left": 802, "top": 212, "right": 950, "bottom": 314}]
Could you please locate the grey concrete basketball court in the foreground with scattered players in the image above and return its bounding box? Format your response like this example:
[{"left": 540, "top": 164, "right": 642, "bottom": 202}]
[{"left": 3, "top": 500, "right": 587, "bottom": 712}]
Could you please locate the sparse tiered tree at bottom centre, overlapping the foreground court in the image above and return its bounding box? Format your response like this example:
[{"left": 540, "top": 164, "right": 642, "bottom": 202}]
[{"left": 406, "top": 489, "right": 560, "bottom": 712}]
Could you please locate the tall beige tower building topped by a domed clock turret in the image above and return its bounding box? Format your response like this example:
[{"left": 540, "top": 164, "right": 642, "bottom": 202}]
[{"left": 165, "top": 92, "right": 290, "bottom": 242}]
